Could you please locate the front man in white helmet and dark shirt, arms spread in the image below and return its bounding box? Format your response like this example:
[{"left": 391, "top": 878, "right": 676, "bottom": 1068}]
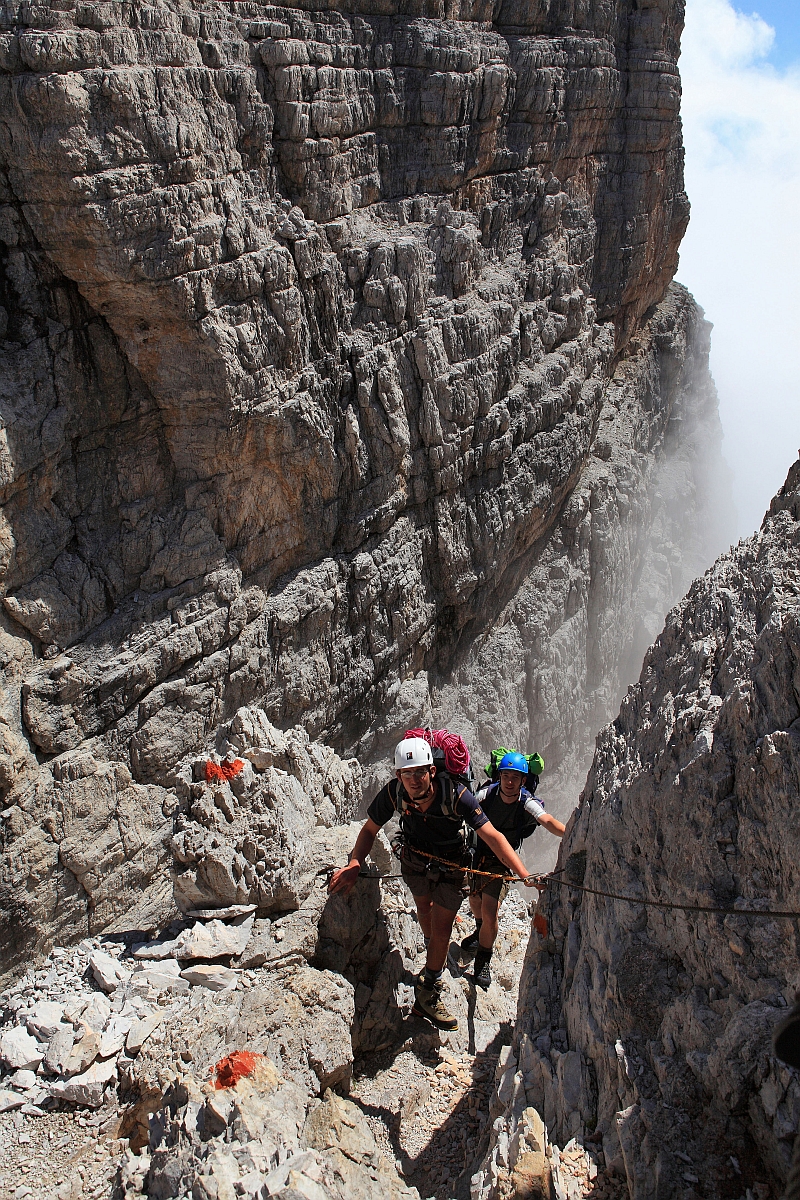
[{"left": 329, "top": 738, "right": 534, "bottom": 1030}]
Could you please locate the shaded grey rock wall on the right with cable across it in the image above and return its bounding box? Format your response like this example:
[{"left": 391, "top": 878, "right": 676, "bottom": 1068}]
[{"left": 503, "top": 463, "right": 800, "bottom": 1200}]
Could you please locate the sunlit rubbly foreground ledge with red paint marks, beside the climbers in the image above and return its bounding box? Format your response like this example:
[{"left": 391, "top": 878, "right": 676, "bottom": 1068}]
[{"left": 0, "top": 709, "right": 537, "bottom": 1200}]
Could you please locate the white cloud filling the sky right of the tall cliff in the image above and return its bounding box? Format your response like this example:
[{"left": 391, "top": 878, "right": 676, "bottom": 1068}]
[{"left": 678, "top": 0, "right": 800, "bottom": 535}]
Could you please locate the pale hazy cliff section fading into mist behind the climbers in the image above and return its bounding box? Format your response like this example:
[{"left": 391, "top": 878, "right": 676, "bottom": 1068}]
[{"left": 371, "top": 286, "right": 729, "bottom": 869}]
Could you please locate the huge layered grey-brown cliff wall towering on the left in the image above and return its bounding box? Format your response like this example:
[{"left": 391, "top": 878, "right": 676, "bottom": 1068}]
[{"left": 0, "top": 0, "right": 718, "bottom": 968}]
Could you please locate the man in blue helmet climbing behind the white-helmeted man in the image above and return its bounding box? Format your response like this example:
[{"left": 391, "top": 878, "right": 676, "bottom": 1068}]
[{"left": 459, "top": 751, "right": 564, "bottom": 988}]
